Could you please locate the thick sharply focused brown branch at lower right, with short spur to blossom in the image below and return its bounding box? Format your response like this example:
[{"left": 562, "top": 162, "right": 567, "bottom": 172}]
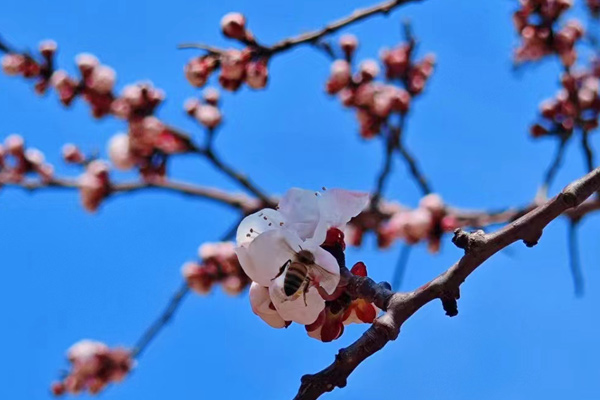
[{"left": 295, "top": 168, "right": 600, "bottom": 400}]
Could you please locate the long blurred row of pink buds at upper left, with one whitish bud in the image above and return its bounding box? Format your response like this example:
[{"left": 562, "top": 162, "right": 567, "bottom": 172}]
[{"left": 2, "top": 41, "right": 192, "bottom": 185}]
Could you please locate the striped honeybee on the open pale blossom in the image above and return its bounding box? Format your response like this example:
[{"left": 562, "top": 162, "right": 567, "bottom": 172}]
[{"left": 271, "top": 249, "right": 337, "bottom": 306}]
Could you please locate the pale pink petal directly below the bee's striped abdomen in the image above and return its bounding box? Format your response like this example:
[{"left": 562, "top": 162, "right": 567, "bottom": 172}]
[{"left": 269, "top": 275, "right": 325, "bottom": 325}]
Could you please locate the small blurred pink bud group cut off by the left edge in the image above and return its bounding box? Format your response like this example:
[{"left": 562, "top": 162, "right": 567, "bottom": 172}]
[{"left": 0, "top": 135, "right": 54, "bottom": 184}]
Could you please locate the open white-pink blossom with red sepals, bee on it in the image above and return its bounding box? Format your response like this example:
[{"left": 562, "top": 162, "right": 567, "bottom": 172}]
[{"left": 236, "top": 189, "right": 377, "bottom": 341}]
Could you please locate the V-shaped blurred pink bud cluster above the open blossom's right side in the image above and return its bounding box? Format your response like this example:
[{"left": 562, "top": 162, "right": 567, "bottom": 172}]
[{"left": 326, "top": 35, "right": 435, "bottom": 138}]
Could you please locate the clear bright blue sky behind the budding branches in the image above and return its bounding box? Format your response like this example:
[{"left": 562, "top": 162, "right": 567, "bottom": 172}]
[{"left": 0, "top": 0, "right": 600, "bottom": 400}]
